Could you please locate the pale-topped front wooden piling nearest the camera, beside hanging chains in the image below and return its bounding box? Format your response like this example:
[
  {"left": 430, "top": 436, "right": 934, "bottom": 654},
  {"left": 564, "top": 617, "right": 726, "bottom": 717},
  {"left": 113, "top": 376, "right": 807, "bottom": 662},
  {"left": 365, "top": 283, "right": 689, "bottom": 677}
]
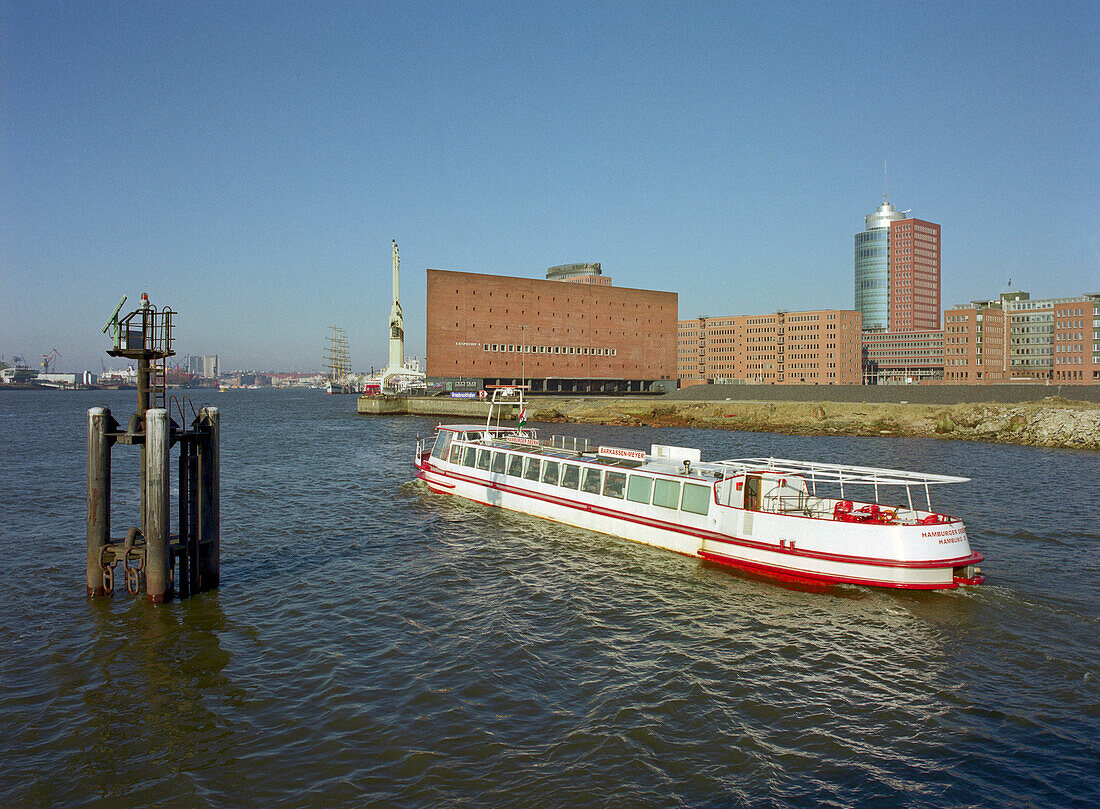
[{"left": 144, "top": 407, "right": 173, "bottom": 604}]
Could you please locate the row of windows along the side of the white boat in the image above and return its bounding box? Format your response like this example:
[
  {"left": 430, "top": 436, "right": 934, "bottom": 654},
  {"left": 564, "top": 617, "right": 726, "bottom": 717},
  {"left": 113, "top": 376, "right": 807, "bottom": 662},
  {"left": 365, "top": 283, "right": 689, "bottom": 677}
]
[{"left": 451, "top": 445, "right": 711, "bottom": 514}]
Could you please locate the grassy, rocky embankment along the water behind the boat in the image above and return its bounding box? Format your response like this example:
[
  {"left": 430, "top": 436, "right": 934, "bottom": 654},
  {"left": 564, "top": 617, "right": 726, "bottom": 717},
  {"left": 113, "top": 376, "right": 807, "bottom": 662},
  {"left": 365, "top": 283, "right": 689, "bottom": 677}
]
[{"left": 529, "top": 396, "right": 1100, "bottom": 450}]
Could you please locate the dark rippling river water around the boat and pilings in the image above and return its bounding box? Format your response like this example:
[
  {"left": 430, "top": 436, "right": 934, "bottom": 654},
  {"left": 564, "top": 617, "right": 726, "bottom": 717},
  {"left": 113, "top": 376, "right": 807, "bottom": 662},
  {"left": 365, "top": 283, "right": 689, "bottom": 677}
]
[{"left": 0, "top": 391, "right": 1100, "bottom": 808}]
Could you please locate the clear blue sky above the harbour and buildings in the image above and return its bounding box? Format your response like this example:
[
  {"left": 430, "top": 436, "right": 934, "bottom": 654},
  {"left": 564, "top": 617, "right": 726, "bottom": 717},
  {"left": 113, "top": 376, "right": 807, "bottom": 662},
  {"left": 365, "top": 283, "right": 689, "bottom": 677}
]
[{"left": 0, "top": 0, "right": 1100, "bottom": 371}]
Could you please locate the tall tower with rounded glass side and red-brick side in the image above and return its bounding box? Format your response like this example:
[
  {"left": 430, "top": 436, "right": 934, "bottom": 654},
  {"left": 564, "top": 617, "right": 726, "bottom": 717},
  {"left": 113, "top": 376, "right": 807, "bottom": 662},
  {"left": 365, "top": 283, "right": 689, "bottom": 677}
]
[{"left": 856, "top": 197, "right": 941, "bottom": 332}]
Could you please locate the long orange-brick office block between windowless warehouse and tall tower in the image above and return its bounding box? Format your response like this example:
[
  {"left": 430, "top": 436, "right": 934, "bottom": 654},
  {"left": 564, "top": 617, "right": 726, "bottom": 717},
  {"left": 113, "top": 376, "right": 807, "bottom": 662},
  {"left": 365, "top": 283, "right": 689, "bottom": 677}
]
[{"left": 677, "top": 309, "right": 860, "bottom": 387}]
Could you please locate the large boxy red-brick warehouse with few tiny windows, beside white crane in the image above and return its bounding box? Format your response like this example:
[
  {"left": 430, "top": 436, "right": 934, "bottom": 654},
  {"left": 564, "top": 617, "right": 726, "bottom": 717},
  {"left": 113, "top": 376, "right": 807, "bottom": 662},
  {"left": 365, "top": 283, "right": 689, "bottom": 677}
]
[{"left": 426, "top": 270, "right": 678, "bottom": 393}]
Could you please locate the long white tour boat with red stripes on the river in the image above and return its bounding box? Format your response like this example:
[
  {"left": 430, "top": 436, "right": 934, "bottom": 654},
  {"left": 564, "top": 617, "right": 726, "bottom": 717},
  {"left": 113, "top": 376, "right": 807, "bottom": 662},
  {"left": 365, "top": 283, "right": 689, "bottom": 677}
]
[{"left": 415, "top": 387, "right": 985, "bottom": 590}]
